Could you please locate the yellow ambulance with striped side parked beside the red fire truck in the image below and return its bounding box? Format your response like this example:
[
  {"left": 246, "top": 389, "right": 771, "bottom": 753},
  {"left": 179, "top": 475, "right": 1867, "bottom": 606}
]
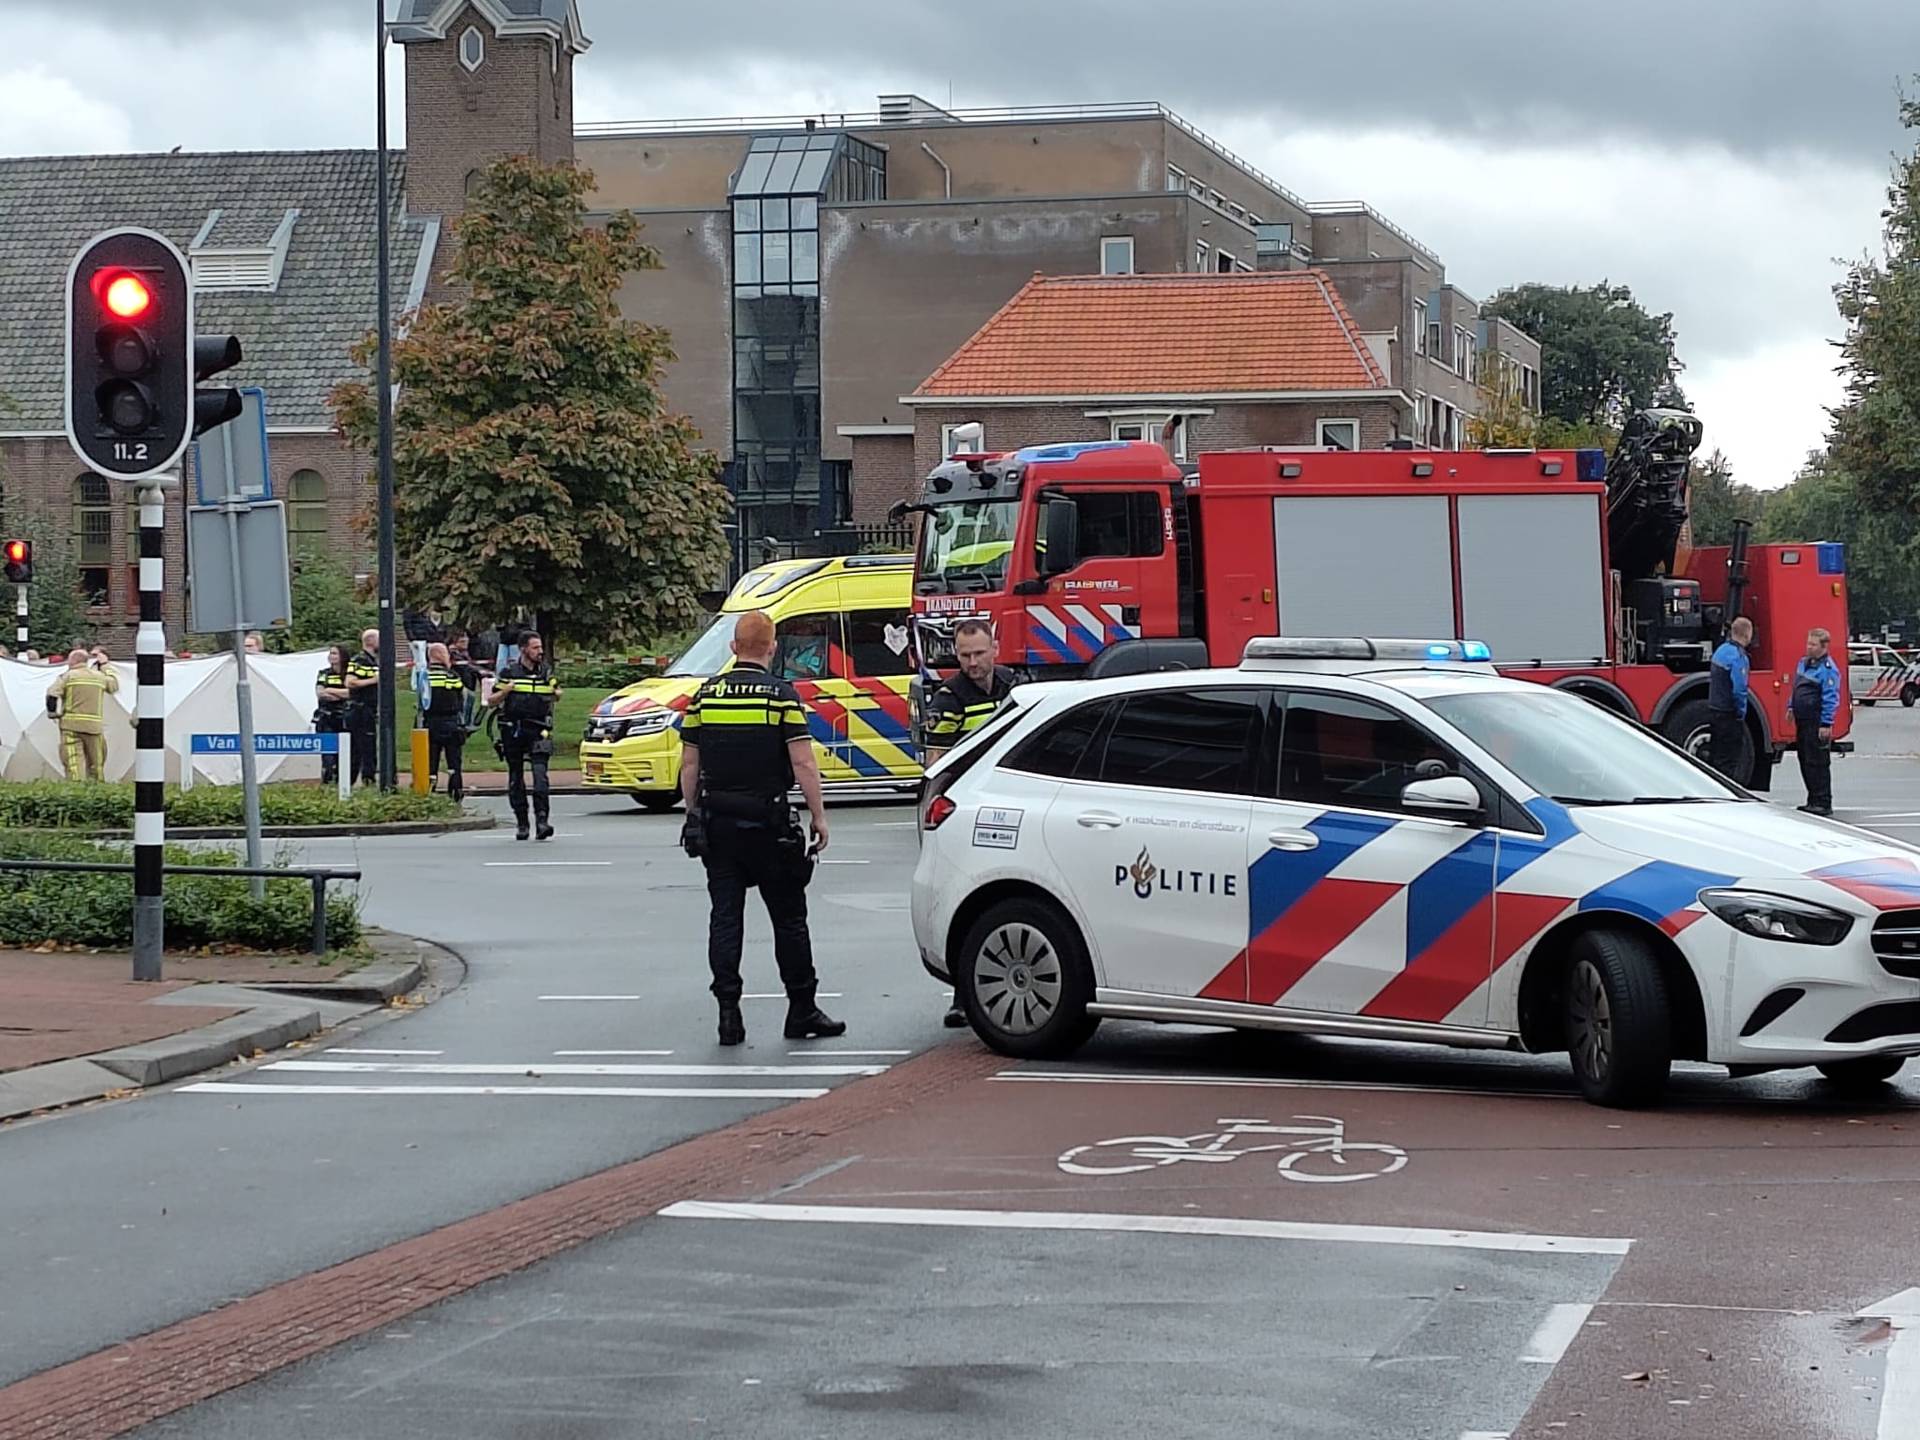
[{"left": 580, "top": 555, "right": 920, "bottom": 810}]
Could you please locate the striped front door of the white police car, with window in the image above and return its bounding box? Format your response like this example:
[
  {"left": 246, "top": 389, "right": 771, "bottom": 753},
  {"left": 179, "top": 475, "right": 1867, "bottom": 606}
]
[{"left": 1210, "top": 687, "right": 1496, "bottom": 1025}]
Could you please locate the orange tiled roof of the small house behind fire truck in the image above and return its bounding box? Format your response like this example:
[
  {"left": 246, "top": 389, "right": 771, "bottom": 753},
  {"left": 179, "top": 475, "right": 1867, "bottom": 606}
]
[{"left": 916, "top": 271, "right": 1388, "bottom": 399}]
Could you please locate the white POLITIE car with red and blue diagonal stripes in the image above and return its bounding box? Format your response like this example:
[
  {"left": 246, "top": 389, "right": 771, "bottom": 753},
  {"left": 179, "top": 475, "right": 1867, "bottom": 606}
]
[{"left": 914, "top": 639, "right": 1920, "bottom": 1104}]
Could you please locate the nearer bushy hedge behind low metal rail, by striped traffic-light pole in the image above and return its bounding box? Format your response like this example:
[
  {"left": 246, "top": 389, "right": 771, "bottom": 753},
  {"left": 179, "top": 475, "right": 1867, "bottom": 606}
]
[{"left": 0, "top": 833, "right": 361, "bottom": 950}]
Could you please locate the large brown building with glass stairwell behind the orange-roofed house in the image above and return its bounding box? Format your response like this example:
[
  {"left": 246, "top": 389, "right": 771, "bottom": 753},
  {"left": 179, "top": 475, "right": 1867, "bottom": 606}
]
[{"left": 576, "top": 96, "right": 1540, "bottom": 536}]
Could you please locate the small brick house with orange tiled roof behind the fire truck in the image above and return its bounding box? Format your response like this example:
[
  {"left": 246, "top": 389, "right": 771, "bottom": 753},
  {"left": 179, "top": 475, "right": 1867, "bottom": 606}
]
[{"left": 871, "top": 271, "right": 1405, "bottom": 522}]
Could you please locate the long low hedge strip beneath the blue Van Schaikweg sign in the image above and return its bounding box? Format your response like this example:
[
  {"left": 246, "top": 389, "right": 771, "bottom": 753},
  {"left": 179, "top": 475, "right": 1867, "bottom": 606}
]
[{"left": 0, "top": 780, "right": 461, "bottom": 829}]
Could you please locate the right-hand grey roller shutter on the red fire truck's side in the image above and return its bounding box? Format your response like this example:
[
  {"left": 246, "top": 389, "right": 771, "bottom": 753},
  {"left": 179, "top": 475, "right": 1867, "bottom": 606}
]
[{"left": 1459, "top": 495, "right": 1607, "bottom": 664}]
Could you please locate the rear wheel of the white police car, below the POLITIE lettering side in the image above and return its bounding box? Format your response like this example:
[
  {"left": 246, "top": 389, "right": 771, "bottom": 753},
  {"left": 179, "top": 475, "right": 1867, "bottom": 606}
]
[{"left": 954, "top": 900, "right": 1100, "bottom": 1058}]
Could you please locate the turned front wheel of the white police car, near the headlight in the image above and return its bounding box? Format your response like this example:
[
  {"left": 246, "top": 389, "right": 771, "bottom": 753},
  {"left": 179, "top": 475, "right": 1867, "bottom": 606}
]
[{"left": 1565, "top": 929, "right": 1672, "bottom": 1110}]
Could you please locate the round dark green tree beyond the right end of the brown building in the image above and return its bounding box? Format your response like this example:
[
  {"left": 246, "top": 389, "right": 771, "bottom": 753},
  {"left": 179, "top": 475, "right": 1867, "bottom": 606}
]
[{"left": 1486, "top": 280, "right": 1686, "bottom": 426}]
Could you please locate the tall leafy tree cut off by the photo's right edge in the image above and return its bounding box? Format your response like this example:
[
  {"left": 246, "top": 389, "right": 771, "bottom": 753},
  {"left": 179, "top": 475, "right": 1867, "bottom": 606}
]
[{"left": 1832, "top": 81, "right": 1920, "bottom": 515}]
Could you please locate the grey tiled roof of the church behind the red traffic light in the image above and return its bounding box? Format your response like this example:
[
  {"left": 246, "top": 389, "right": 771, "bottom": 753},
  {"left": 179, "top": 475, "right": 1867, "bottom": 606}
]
[{"left": 0, "top": 150, "right": 434, "bottom": 434}]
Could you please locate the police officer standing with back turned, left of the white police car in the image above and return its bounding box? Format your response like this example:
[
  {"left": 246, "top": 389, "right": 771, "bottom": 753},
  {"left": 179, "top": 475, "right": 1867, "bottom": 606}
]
[{"left": 680, "top": 611, "right": 847, "bottom": 1044}]
